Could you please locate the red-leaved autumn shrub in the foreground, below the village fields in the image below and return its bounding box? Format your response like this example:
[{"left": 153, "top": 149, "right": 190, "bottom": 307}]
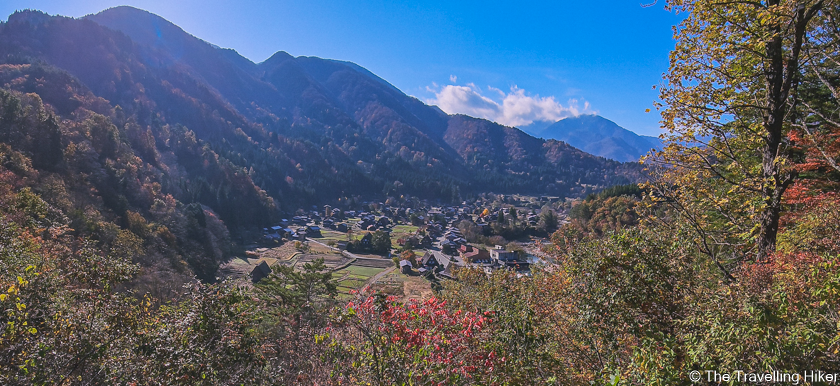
[{"left": 326, "top": 292, "right": 498, "bottom": 385}]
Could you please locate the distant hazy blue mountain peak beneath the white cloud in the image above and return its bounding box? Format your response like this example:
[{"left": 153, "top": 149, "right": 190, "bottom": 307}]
[{"left": 522, "top": 115, "right": 662, "bottom": 162}]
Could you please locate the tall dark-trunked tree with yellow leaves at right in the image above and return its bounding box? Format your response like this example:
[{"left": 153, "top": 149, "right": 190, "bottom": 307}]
[{"left": 655, "top": 0, "right": 826, "bottom": 260}]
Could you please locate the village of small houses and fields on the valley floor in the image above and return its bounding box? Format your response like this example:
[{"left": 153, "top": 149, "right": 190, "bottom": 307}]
[{"left": 223, "top": 195, "right": 569, "bottom": 299}]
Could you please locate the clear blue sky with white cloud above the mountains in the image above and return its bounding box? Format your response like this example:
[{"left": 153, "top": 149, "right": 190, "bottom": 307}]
[{"left": 0, "top": 0, "right": 679, "bottom": 135}]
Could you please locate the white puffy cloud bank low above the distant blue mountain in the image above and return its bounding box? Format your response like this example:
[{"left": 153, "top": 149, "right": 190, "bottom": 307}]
[{"left": 426, "top": 81, "right": 595, "bottom": 126}]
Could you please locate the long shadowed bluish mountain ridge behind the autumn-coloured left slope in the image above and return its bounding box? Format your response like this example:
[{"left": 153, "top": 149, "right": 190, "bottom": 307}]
[{"left": 0, "top": 7, "right": 640, "bottom": 225}]
